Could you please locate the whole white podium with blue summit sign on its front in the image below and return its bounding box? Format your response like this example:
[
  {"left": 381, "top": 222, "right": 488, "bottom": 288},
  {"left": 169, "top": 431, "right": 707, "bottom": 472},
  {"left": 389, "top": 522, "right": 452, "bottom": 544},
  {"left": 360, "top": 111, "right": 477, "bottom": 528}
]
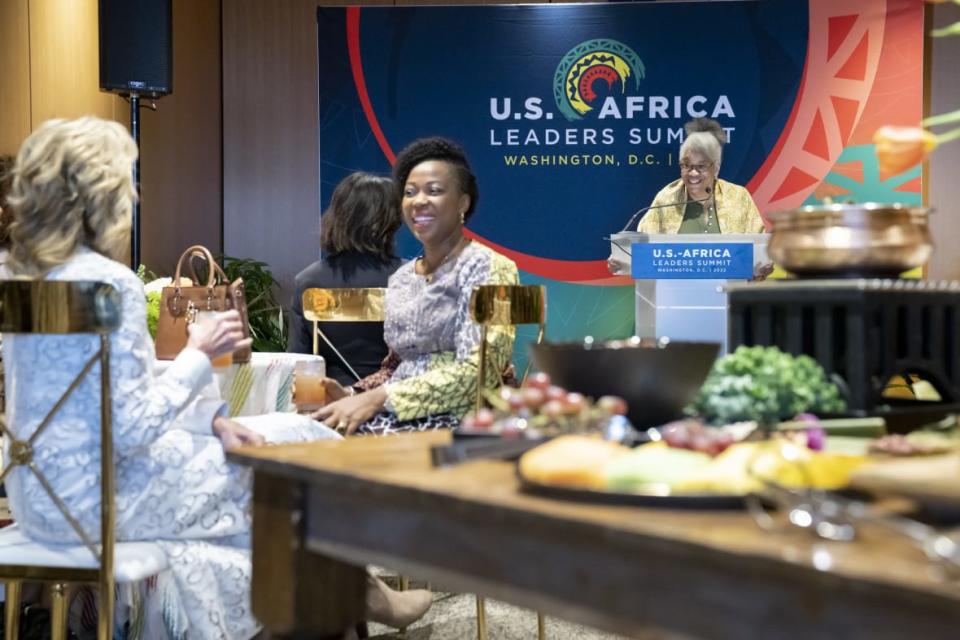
[{"left": 610, "top": 231, "right": 769, "bottom": 355}]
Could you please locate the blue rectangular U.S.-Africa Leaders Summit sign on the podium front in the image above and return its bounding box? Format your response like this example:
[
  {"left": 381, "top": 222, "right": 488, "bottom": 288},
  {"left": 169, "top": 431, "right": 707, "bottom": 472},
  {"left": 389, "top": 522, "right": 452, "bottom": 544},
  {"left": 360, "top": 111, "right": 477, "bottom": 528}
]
[{"left": 630, "top": 242, "right": 753, "bottom": 280}]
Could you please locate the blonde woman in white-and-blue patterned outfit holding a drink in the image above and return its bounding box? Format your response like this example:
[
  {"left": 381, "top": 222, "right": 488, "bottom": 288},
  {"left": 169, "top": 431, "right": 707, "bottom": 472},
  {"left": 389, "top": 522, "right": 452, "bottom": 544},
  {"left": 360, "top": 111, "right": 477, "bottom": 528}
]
[{"left": 3, "top": 117, "right": 352, "bottom": 639}]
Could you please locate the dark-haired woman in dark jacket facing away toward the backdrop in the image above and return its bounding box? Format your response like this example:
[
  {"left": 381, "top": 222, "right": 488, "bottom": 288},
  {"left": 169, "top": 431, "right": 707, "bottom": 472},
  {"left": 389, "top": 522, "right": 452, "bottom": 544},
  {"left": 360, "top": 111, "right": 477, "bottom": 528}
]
[{"left": 287, "top": 173, "right": 403, "bottom": 384}]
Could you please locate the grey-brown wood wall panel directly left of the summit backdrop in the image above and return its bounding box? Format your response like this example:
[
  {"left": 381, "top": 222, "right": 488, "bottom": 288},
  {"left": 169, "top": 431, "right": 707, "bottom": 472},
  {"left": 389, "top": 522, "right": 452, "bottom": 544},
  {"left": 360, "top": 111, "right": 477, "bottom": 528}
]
[{"left": 223, "top": 0, "right": 320, "bottom": 302}]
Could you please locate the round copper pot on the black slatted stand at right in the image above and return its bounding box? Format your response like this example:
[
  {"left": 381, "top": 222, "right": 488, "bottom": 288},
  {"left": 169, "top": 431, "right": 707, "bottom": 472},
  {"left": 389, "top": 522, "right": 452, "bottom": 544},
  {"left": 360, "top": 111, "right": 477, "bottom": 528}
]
[{"left": 767, "top": 202, "right": 933, "bottom": 277}]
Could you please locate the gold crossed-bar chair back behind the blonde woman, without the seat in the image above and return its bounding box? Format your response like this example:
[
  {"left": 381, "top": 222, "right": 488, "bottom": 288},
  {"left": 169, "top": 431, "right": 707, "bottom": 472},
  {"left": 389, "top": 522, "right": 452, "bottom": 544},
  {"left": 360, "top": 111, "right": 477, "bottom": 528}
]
[{"left": 0, "top": 280, "right": 121, "bottom": 638}]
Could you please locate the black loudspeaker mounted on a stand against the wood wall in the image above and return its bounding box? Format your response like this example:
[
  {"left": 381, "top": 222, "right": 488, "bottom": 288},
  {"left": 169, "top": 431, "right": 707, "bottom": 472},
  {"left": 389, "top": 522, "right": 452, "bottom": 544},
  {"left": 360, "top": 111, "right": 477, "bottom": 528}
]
[{"left": 100, "top": 0, "right": 173, "bottom": 98}]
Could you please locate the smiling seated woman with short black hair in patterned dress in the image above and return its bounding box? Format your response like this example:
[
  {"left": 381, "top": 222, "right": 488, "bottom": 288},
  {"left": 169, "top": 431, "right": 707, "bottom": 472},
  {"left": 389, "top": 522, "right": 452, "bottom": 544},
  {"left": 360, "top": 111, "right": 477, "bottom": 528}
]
[{"left": 314, "top": 138, "right": 518, "bottom": 435}]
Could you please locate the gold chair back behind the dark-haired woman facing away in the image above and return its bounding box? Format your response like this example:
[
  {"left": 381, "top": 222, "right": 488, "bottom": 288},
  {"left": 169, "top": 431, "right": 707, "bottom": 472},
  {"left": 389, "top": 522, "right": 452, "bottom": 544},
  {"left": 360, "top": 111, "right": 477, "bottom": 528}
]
[{"left": 303, "top": 287, "right": 386, "bottom": 380}]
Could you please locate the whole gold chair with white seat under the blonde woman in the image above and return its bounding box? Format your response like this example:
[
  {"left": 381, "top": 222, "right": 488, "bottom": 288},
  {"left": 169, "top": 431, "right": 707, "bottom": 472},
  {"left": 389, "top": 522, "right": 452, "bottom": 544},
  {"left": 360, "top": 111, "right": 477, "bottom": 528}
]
[{"left": 0, "top": 280, "right": 168, "bottom": 640}]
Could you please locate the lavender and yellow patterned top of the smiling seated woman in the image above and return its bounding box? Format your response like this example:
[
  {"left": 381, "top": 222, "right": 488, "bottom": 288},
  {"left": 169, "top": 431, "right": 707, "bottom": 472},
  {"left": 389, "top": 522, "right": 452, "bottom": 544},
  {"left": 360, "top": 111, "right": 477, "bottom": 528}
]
[{"left": 383, "top": 242, "right": 519, "bottom": 420}]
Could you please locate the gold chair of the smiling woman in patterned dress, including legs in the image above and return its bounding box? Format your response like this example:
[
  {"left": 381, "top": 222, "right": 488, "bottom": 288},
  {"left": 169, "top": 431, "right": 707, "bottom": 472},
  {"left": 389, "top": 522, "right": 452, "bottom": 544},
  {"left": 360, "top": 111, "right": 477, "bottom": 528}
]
[{"left": 470, "top": 284, "right": 547, "bottom": 640}]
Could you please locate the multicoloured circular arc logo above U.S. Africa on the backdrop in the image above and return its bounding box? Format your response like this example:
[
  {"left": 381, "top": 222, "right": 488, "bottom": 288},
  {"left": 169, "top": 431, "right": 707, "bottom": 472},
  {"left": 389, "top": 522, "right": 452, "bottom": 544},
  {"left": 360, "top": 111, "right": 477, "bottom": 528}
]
[{"left": 553, "top": 38, "right": 644, "bottom": 120}]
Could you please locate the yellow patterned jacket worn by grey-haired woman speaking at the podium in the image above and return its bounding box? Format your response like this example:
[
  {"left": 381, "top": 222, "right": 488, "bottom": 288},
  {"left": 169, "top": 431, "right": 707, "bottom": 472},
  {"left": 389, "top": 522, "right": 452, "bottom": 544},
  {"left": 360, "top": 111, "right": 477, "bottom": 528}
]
[{"left": 637, "top": 179, "right": 765, "bottom": 233}]
